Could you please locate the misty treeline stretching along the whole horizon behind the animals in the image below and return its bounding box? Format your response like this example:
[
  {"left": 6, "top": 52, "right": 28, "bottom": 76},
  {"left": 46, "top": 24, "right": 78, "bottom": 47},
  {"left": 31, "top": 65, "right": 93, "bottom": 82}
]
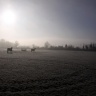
[{"left": 0, "top": 39, "right": 96, "bottom": 51}]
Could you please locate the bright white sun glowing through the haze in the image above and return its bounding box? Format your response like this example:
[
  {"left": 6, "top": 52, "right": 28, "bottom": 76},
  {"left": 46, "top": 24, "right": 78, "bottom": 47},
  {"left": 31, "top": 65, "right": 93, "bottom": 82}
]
[{"left": 2, "top": 9, "right": 16, "bottom": 25}]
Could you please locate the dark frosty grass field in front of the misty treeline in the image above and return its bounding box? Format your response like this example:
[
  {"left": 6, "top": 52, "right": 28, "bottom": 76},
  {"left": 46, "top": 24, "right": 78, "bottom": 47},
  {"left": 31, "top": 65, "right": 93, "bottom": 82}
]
[{"left": 0, "top": 50, "right": 96, "bottom": 96}]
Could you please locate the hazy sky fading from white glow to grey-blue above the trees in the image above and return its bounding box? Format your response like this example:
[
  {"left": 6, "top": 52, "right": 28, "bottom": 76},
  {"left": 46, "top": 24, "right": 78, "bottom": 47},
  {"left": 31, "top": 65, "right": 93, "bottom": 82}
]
[{"left": 0, "top": 0, "right": 96, "bottom": 45}]
